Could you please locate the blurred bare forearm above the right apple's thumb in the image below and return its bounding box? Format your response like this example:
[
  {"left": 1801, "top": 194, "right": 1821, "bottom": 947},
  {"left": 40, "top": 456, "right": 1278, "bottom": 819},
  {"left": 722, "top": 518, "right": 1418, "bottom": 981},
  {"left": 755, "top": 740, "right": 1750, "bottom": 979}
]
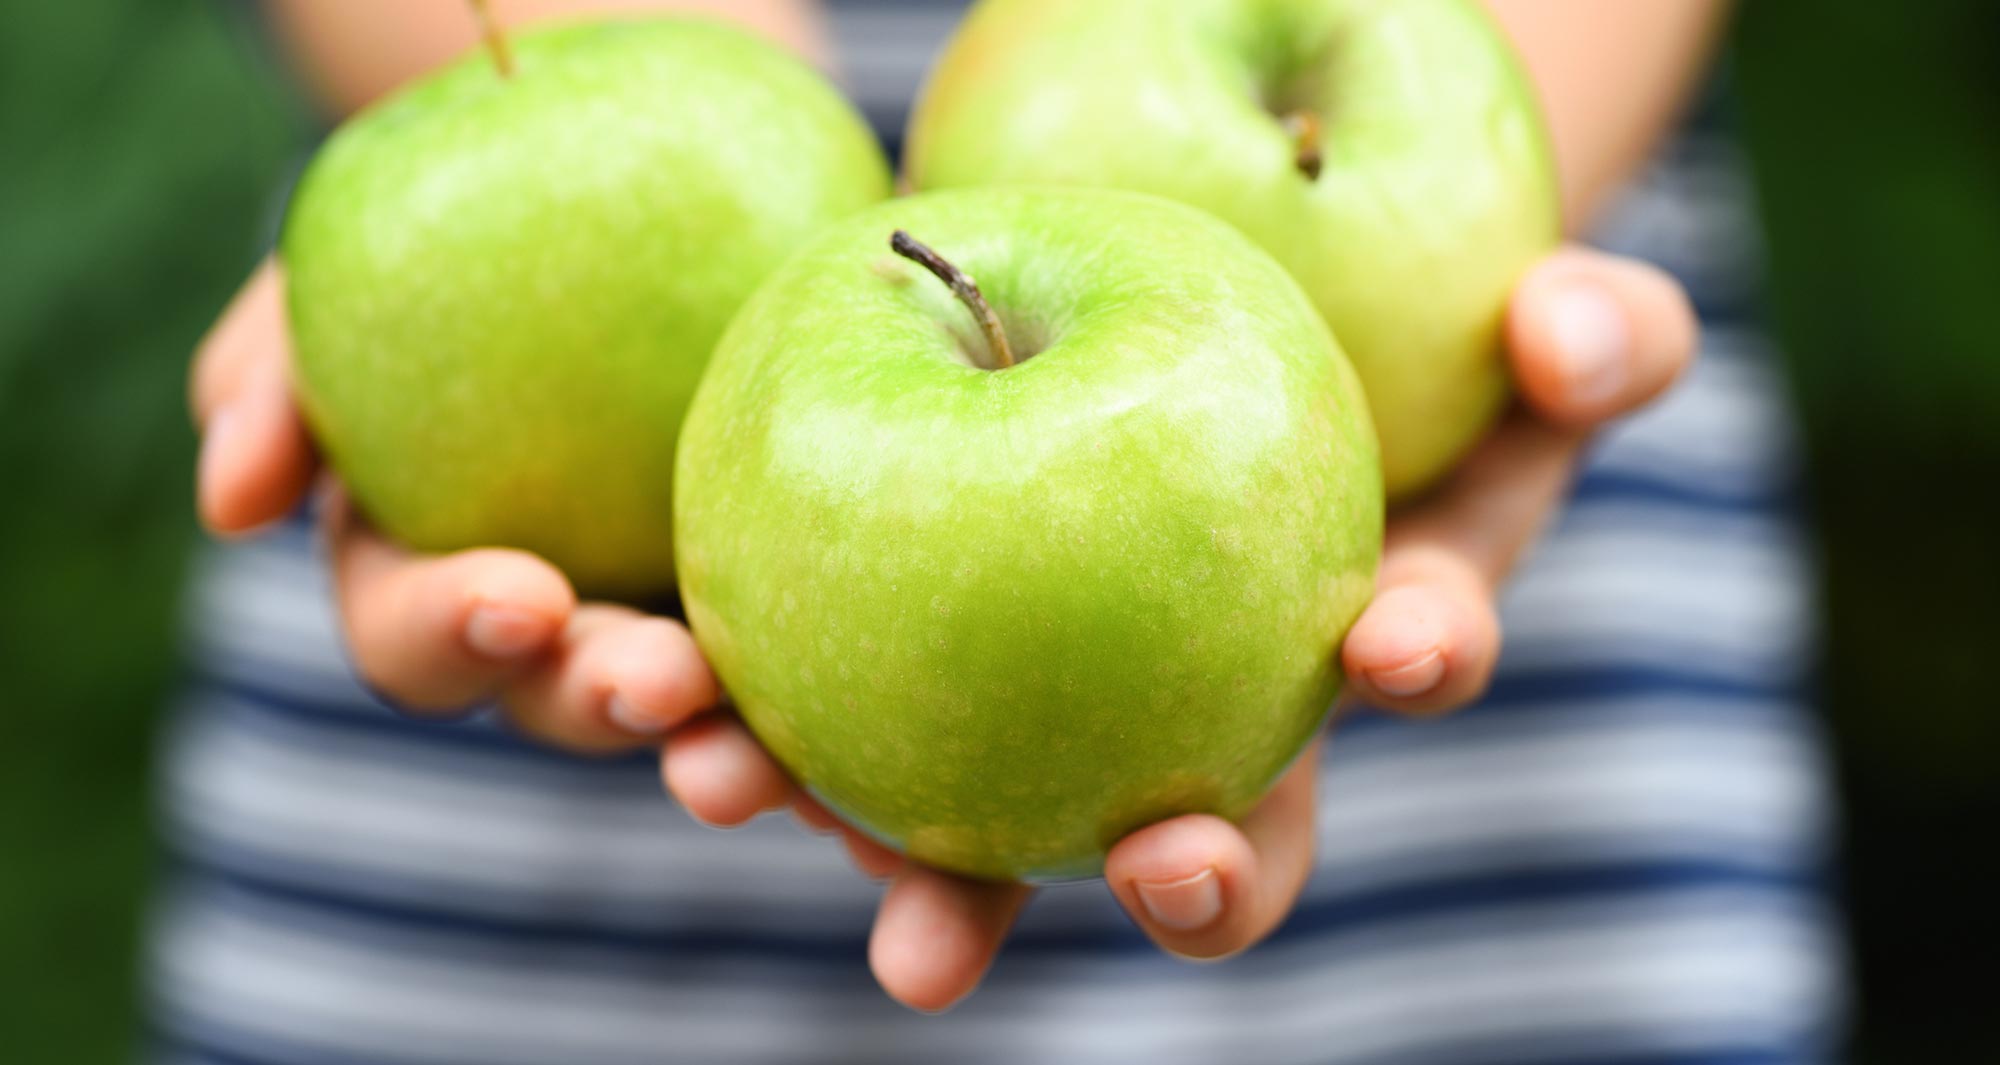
[{"left": 1488, "top": 0, "right": 1728, "bottom": 230}]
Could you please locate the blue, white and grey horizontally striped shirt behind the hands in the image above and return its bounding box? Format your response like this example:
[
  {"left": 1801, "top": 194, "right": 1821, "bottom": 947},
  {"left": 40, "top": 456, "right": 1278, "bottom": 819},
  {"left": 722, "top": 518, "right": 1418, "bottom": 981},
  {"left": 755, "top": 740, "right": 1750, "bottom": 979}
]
[{"left": 152, "top": 0, "right": 1842, "bottom": 1065}]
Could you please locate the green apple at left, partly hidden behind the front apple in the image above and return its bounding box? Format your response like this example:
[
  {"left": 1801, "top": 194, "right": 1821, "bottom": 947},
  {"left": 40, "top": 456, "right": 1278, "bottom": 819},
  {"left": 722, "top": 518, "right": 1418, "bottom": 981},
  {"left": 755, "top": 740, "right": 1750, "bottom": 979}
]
[{"left": 282, "top": 20, "right": 890, "bottom": 597}]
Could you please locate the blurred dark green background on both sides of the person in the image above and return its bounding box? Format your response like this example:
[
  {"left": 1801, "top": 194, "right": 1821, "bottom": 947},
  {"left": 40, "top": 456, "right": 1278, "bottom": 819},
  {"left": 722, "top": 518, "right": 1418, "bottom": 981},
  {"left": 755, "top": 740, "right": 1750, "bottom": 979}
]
[{"left": 0, "top": 0, "right": 2000, "bottom": 1065}]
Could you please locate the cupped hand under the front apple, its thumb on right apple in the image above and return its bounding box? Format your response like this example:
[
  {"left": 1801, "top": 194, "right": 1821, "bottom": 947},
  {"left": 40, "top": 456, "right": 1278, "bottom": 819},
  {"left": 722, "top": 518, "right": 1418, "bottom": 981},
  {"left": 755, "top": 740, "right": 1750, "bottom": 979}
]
[{"left": 664, "top": 248, "right": 1696, "bottom": 1011}]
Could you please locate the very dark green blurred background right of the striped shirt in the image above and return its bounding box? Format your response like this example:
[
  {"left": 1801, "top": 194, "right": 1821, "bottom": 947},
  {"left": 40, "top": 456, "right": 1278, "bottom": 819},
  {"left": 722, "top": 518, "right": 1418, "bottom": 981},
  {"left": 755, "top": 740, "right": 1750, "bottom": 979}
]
[{"left": 1736, "top": 0, "right": 2000, "bottom": 1065}]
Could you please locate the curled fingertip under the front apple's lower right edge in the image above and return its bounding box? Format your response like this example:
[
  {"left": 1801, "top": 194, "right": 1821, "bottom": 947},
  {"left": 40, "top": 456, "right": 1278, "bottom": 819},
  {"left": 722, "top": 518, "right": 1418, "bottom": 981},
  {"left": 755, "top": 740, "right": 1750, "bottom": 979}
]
[{"left": 1104, "top": 743, "right": 1320, "bottom": 959}]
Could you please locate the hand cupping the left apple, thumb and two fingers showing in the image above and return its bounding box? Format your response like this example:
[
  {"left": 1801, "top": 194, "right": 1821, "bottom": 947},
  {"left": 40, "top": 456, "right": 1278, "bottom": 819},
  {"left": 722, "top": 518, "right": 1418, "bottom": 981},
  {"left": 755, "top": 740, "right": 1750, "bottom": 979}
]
[{"left": 190, "top": 260, "right": 720, "bottom": 753}]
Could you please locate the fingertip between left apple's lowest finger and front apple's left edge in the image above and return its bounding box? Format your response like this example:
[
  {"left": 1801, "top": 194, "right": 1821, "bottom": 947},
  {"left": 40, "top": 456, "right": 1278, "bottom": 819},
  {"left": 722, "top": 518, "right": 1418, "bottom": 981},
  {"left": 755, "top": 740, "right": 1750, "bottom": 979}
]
[{"left": 500, "top": 603, "right": 720, "bottom": 753}]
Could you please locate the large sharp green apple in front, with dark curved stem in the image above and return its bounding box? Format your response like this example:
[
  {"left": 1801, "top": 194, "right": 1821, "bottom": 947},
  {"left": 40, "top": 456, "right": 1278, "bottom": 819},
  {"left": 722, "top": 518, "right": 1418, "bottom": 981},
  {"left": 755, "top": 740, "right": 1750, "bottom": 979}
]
[{"left": 676, "top": 188, "right": 1382, "bottom": 879}]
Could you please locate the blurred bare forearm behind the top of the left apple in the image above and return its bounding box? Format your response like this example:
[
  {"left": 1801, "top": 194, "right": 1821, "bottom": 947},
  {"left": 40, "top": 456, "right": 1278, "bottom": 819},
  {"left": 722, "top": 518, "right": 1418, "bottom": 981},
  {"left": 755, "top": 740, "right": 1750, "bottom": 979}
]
[{"left": 266, "top": 0, "right": 826, "bottom": 116}]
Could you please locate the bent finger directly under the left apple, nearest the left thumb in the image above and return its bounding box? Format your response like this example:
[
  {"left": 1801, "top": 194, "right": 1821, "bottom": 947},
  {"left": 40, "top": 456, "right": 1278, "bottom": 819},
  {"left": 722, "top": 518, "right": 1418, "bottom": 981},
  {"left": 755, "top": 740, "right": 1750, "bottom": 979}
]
[{"left": 324, "top": 492, "right": 576, "bottom": 711}]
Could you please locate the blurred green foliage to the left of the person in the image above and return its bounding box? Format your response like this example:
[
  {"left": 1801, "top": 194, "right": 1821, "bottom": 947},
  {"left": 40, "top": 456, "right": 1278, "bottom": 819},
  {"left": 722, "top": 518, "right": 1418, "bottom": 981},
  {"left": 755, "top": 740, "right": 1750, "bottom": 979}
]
[{"left": 0, "top": 0, "right": 302, "bottom": 1063}]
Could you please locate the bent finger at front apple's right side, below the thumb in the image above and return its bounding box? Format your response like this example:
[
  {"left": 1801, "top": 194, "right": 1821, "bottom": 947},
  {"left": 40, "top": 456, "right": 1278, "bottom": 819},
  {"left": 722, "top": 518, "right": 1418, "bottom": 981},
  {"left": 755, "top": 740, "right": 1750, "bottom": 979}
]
[{"left": 1340, "top": 412, "right": 1582, "bottom": 713}]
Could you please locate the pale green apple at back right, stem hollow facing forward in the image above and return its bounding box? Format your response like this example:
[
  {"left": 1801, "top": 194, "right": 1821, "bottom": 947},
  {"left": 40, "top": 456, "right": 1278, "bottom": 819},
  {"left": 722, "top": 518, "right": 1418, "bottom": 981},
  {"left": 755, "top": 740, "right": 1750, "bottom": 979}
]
[{"left": 906, "top": 0, "right": 1560, "bottom": 496}]
